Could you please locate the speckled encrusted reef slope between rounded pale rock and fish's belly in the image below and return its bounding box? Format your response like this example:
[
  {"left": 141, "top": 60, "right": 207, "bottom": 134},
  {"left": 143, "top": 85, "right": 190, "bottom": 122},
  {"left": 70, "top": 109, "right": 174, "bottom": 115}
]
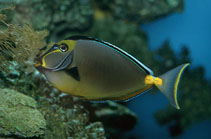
[{"left": 0, "top": 63, "right": 105, "bottom": 139}]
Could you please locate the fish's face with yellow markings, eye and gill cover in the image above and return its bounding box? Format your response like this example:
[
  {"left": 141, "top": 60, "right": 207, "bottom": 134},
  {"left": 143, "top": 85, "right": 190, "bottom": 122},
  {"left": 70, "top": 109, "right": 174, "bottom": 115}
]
[{"left": 41, "top": 40, "right": 76, "bottom": 71}]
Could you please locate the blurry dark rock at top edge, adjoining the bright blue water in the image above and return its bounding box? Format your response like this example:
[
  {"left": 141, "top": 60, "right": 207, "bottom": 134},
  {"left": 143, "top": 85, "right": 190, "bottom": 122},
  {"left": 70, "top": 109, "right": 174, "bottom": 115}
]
[{"left": 94, "top": 0, "right": 183, "bottom": 23}]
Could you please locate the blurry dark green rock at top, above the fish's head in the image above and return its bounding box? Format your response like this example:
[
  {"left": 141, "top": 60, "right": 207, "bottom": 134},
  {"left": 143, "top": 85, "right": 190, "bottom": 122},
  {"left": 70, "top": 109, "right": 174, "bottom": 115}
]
[{"left": 10, "top": 0, "right": 93, "bottom": 40}]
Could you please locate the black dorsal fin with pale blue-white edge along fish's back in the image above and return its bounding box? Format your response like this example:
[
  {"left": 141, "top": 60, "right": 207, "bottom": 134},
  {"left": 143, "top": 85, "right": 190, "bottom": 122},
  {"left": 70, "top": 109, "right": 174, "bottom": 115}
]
[{"left": 66, "top": 35, "right": 153, "bottom": 75}]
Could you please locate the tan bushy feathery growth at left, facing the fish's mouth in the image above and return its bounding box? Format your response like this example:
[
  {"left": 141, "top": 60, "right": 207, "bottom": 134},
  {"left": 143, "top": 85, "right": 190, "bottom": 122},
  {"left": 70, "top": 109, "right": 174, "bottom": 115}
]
[{"left": 0, "top": 6, "right": 48, "bottom": 71}]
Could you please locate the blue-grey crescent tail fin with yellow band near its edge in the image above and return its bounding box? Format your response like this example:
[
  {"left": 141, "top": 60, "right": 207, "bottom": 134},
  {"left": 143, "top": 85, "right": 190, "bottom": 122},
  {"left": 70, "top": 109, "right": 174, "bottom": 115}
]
[{"left": 156, "top": 63, "right": 189, "bottom": 109}]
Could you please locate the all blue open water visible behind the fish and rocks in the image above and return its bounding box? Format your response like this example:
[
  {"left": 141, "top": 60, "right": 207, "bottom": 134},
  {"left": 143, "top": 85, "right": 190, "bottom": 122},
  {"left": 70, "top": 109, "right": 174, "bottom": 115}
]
[{"left": 129, "top": 0, "right": 211, "bottom": 139}]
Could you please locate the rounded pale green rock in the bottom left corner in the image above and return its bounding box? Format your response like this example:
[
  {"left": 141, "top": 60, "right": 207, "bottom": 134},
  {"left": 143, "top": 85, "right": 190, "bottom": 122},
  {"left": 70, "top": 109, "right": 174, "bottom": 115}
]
[{"left": 0, "top": 89, "right": 46, "bottom": 137}]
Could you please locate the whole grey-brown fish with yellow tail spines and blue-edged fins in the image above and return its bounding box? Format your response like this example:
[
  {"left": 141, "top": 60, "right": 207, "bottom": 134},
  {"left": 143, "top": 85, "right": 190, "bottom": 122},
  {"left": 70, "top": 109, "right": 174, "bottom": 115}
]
[{"left": 35, "top": 36, "right": 189, "bottom": 109}]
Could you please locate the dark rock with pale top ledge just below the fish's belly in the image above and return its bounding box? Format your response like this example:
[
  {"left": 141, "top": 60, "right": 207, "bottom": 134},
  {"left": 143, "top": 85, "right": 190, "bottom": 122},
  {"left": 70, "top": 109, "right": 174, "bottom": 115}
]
[{"left": 90, "top": 101, "right": 138, "bottom": 138}]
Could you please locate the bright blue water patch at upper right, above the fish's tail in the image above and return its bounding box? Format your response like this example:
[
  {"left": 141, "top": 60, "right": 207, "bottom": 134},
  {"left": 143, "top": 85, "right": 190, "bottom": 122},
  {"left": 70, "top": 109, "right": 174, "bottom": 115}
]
[{"left": 141, "top": 0, "right": 211, "bottom": 79}]
